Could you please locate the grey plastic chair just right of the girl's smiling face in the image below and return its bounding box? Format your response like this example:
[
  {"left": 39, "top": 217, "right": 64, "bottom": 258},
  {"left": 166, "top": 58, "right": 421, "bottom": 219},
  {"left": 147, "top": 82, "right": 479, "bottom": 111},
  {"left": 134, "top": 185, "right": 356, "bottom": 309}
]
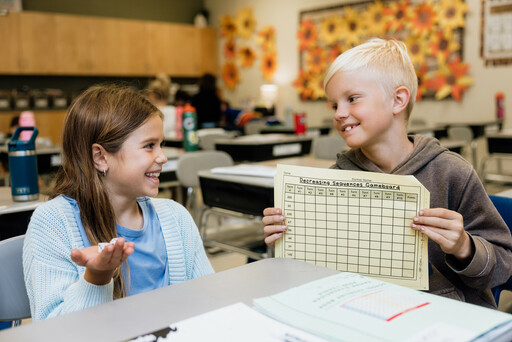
[{"left": 176, "top": 151, "right": 233, "bottom": 220}]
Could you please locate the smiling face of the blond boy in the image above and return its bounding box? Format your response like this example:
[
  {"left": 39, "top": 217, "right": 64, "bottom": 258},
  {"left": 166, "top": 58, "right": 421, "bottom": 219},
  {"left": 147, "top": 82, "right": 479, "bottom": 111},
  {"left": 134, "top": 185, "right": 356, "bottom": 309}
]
[{"left": 326, "top": 70, "right": 394, "bottom": 148}]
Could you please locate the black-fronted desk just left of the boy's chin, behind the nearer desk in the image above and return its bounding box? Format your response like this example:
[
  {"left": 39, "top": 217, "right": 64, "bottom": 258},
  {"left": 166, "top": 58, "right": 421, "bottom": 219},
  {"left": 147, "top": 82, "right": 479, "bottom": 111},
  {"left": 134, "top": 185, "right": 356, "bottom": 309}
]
[{"left": 215, "top": 134, "right": 313, "bottom": 161}]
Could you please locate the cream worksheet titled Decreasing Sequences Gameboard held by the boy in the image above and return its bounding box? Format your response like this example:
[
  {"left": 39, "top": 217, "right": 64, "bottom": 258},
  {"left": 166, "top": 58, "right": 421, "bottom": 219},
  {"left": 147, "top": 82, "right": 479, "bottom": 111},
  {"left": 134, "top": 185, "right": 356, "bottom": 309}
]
[{"left": 274, "top": 164, "right": 430, "bottom": 290}]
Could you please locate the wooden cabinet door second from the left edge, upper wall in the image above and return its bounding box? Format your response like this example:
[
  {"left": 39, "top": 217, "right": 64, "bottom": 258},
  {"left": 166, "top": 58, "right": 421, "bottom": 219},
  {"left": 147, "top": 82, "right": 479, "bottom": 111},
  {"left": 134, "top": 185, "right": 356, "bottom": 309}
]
[{"left": 19, "top": 12, "right": 58, "bottom": 75}]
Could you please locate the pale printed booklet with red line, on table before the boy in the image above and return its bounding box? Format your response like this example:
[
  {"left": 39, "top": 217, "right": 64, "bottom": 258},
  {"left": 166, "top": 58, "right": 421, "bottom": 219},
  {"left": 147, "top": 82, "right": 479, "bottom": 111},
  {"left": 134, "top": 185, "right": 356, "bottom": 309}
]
[{"left": 253, "top": 272, "right": 512, "bottom": 342}]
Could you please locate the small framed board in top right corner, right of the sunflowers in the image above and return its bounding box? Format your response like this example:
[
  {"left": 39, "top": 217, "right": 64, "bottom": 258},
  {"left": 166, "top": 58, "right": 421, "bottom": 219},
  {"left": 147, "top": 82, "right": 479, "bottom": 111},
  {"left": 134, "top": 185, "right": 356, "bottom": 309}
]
[{"left": 481, "top": 0, "right": 512, "bottom": 65}]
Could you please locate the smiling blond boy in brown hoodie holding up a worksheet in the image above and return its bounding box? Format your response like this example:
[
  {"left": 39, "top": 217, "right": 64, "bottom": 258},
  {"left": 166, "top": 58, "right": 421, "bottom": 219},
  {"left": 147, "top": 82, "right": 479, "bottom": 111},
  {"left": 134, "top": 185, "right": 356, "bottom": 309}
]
[{"left": 262, "top": 39, "right": 512, "bottom": 308}]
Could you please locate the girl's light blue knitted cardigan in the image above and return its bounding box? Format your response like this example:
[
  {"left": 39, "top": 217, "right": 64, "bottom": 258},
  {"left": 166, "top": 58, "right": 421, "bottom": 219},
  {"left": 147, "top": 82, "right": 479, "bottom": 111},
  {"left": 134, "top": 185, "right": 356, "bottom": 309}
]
[{"left": 23, "top": 196, "right": 213, "bottom": 320}]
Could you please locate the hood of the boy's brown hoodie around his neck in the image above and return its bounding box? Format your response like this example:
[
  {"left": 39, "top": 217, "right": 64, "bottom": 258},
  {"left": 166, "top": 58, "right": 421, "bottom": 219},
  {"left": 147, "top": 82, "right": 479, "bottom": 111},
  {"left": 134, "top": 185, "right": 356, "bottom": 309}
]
[{"left": 335, "top": 134, "right": 448, "bottom": 175}]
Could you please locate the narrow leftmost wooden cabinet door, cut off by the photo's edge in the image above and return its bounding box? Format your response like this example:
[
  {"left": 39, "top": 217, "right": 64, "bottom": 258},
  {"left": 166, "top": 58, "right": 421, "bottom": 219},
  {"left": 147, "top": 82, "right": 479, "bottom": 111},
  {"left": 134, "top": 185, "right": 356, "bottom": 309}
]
[{"left": 0, "top": 13, "right": 20, "bottom": 74}]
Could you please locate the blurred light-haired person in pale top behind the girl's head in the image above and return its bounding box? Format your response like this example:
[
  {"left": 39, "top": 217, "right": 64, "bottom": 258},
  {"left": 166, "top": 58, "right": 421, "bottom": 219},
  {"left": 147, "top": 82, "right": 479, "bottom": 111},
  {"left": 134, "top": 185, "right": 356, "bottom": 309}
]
[{"left": 146, "top": 73, "right": 176, "bottom": 137}]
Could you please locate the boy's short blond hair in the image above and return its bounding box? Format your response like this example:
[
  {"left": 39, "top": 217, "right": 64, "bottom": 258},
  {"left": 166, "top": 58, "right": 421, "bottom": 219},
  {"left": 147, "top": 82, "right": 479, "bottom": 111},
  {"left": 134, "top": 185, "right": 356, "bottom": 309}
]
[{"left": 324, "top": 38, "right": 418, "bottom": 120}]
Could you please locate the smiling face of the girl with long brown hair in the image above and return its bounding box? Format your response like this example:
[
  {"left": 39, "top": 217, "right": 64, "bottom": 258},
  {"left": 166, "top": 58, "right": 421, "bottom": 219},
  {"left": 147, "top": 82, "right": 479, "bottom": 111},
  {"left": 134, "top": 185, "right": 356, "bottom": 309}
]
[{"left": 104, "top": 114, "right": 167, "bottom": 201}]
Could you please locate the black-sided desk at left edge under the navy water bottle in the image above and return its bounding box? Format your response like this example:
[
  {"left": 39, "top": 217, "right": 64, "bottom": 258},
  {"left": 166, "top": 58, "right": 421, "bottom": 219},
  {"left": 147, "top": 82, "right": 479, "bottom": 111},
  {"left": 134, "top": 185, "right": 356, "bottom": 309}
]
[{"left": 0, "top": 186, "right": 46, "bottom": 240}]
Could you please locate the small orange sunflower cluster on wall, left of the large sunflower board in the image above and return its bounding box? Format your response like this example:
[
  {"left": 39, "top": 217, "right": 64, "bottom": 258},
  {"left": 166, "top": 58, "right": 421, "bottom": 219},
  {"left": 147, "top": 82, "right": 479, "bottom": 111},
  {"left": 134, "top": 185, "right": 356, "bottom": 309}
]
[{"left": 220, "top": 7, "right": 277, "bottom": 90}]
